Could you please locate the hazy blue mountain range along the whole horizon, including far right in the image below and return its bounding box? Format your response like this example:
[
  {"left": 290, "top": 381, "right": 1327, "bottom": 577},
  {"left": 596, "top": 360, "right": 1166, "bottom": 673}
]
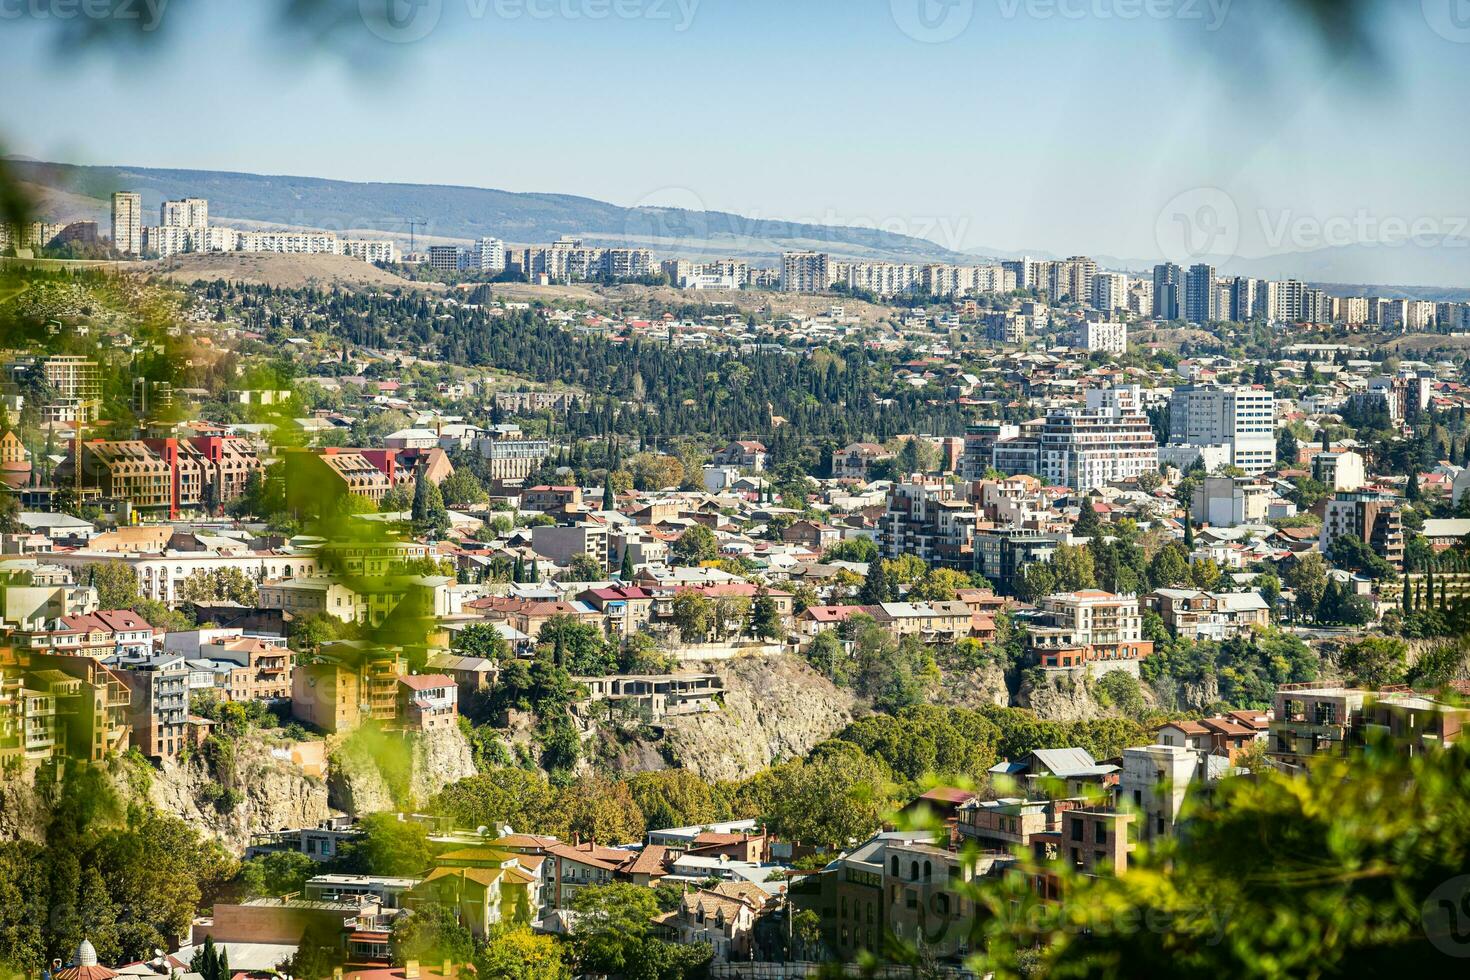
[{"left": 10, "top": 157, "right": 1470, "bottom": 293}]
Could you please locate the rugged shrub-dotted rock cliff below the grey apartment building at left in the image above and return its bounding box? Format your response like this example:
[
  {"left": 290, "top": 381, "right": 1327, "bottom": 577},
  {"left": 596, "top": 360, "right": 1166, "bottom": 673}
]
[{"left": 147, "top": 733, "right": 328, "bottom": 854}]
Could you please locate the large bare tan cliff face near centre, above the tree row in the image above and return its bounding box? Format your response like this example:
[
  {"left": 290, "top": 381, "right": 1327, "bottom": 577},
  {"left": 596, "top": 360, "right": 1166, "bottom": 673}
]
[{"left": 663, "top": 655, "right": 853, "bottom": 780}]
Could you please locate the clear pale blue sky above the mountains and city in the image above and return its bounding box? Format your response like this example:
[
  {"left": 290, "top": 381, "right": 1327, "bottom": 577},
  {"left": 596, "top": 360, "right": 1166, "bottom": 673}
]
[{"left": 0, "top": 0, "right": 1470, "bottom": 260}]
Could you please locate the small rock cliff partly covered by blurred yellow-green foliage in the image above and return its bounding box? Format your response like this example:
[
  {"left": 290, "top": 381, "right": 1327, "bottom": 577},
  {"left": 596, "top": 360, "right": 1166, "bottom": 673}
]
[{"left": 328, "top": 727, "right": 475, "bottom": 817}]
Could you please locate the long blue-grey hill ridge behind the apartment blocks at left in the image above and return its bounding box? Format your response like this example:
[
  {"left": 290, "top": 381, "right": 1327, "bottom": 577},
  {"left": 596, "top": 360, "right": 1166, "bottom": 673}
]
[{"left": 12, "top": 160, "right": 975, "bottom": 263}]
